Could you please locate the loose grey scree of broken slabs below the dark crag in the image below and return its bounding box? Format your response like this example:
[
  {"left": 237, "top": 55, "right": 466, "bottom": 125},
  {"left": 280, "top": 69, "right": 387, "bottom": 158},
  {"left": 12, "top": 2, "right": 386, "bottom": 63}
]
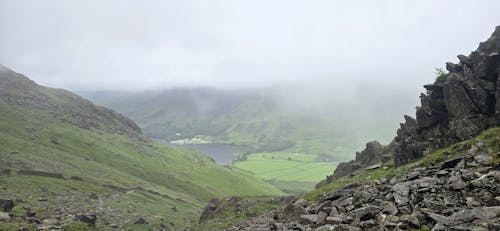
[{"left": 227, "top": 145, "right": 500, "bottom": 231}]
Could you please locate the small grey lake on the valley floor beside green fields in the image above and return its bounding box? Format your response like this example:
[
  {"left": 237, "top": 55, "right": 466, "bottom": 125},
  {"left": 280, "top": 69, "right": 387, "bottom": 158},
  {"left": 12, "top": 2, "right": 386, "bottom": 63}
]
[{"left": 170, "top": 143, "right": 252, "bottom": 165}]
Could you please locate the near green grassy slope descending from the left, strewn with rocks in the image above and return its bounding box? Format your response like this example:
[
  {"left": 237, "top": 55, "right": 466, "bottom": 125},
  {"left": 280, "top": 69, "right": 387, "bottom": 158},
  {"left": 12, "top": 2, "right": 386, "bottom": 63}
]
[{"left": 0, "top": 66, "right": 282, "bottom": 230}]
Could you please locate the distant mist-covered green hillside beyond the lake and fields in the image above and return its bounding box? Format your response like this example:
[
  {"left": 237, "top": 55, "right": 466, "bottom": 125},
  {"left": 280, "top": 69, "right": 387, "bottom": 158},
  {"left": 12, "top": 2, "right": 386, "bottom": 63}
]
[{"left": 82, "top": 88, "right": 413, "bottom": 160}]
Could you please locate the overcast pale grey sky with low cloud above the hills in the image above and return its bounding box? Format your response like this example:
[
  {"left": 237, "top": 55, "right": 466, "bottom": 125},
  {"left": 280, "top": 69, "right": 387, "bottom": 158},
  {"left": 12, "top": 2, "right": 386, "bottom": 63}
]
[{"left": 0, "top": 0, "right": 500, "bottom": 94}]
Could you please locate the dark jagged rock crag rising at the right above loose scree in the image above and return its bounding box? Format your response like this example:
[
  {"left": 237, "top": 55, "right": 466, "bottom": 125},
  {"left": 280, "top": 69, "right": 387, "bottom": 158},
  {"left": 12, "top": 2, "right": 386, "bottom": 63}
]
[{"left": 324, "top": 26, "right": 500, "bottom": 182}]
